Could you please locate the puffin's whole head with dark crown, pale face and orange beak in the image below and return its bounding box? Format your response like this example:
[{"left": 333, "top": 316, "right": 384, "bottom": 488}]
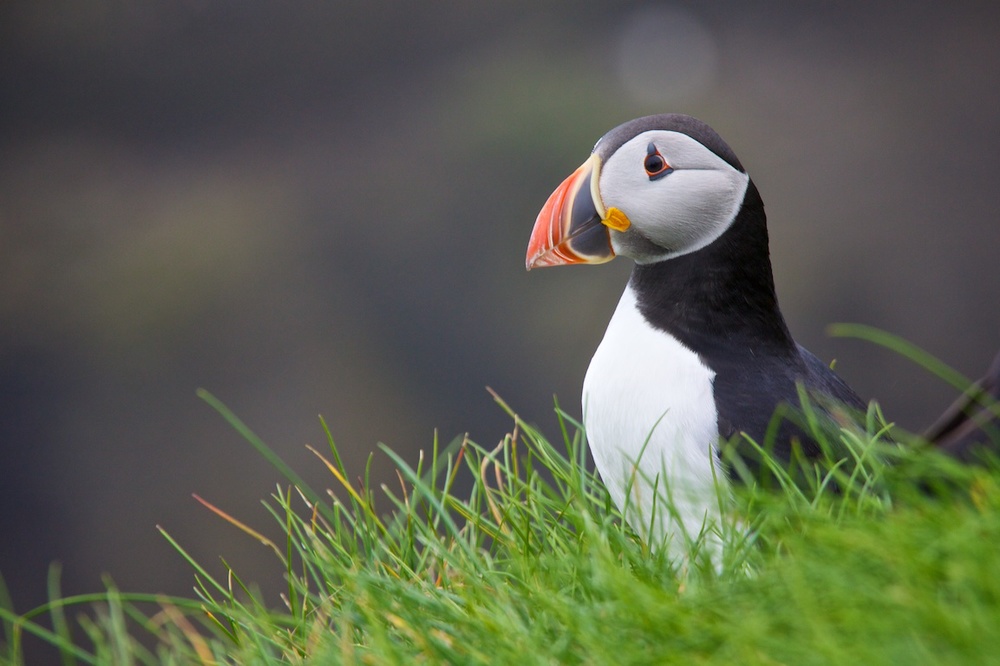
[{"left": 525, "top": 114, "right": 750, "bottom": 270}]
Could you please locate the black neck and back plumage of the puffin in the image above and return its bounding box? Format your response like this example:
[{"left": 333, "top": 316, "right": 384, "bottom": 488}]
[{"left": 628, "top": 178, "right": 865, "bottom": 459}]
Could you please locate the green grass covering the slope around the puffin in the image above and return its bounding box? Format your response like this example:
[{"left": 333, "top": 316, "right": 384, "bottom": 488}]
[{"left": 0, "top": 344, "right": 1000, "bottom": 665}]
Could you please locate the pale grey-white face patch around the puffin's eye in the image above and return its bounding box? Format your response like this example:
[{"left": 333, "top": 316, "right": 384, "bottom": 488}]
[{"left": 599, "top": 130, "right": 750, "bottom": 263}]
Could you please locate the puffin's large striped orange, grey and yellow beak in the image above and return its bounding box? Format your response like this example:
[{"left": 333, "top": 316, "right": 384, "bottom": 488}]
[{"left": 525, "top": 154, "right": 630, "bottom": 271}]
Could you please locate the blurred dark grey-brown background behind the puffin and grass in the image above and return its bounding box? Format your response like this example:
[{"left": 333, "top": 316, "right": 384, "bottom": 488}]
[{"left": 0, "top": 0, "right": 1000, "bottom": 624}]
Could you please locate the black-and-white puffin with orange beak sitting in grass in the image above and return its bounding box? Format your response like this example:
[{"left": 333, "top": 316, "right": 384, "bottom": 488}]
[{"left": 525, "top": 114, "right": 1000, "bottom": 561}]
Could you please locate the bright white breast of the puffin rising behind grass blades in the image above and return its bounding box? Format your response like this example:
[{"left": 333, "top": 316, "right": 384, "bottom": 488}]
[{"left": 583, "top": 287, "right": 727, "bottom": 562}]
